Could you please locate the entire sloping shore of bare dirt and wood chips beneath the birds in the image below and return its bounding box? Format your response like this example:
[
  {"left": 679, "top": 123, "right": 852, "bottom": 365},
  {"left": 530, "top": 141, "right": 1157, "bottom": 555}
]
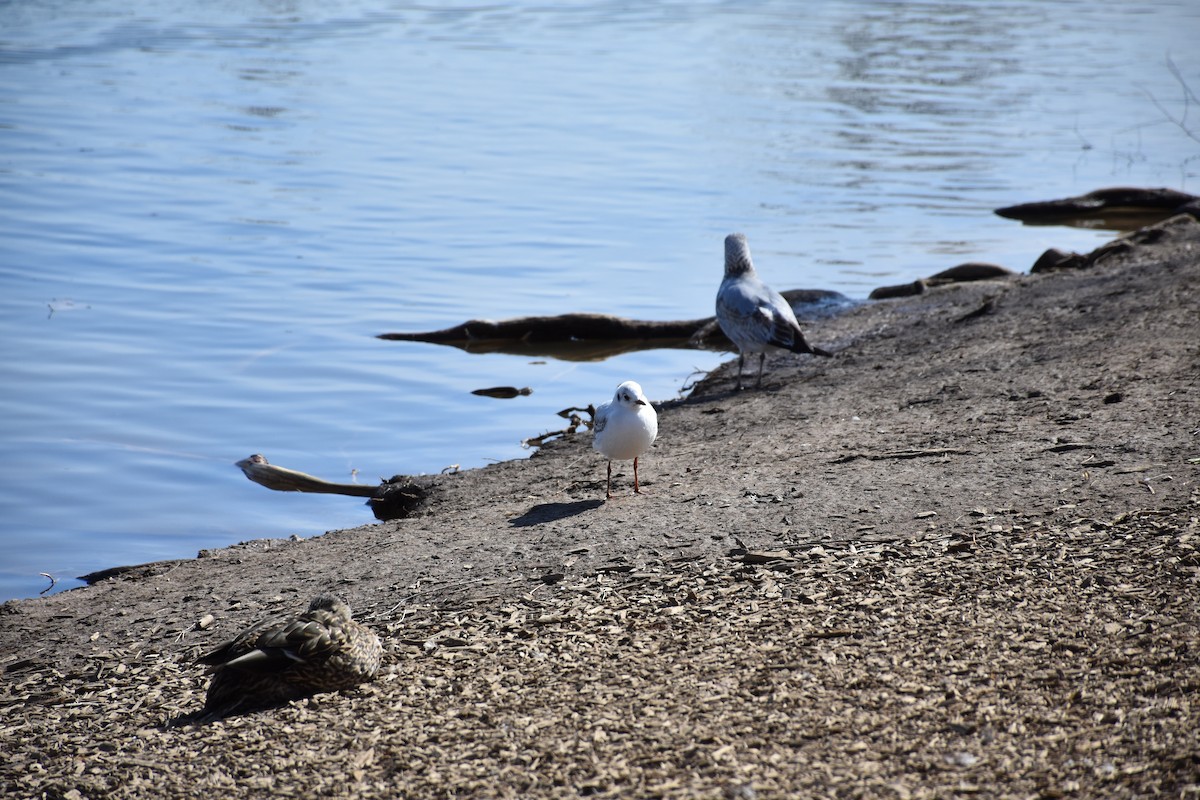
[{"left": 0, "top": 217, "right": 1200, "bottom": 798}]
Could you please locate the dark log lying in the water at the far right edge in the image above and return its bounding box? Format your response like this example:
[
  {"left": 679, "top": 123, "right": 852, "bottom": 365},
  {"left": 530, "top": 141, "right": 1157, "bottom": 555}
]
[{"left": 996, "top": 186, "right": 1200, "bottom": 230}]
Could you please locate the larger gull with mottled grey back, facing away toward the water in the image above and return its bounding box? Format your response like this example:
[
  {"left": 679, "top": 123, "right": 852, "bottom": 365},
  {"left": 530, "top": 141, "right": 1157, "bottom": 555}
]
[{"left": 716, "top": 234, "right": 832, "bottom": 389}]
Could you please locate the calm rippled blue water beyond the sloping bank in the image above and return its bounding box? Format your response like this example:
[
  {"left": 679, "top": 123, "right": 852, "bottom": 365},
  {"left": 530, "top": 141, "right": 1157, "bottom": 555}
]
[{"left": 0, "top": 0, "right": 1200, "bottom": 600}]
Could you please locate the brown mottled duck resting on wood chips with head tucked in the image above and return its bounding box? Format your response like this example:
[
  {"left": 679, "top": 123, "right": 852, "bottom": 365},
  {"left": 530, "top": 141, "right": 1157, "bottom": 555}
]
[{"left": 198, "top": 595, "right": 383, "bottom": 718}]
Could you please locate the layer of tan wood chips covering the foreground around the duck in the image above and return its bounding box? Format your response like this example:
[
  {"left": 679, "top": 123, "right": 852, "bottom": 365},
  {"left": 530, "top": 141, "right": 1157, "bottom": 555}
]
[{"left": 0, "top": 498, "right": 1200, "bottom": 799}]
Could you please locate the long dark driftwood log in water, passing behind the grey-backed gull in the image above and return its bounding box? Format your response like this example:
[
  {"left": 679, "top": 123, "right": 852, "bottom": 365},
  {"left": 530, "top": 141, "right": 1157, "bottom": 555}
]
[{"left": 378, "top": 289, "right": 854, "bottom": 361}]
